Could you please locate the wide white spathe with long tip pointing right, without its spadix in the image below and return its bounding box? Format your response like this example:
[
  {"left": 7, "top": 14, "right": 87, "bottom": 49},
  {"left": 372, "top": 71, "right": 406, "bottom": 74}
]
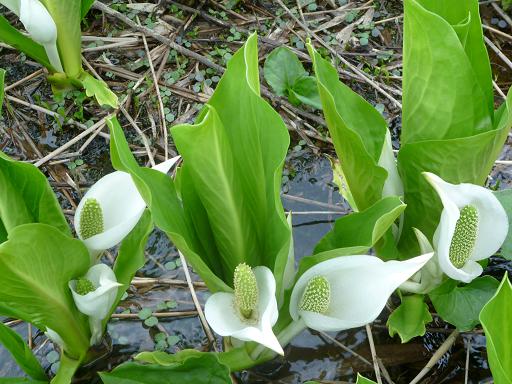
[{"left": 290, "top": 253, "right": 433, "bottom": 331}]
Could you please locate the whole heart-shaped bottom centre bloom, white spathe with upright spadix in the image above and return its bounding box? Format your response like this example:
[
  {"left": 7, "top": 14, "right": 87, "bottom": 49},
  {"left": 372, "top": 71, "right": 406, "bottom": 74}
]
[{"left": 204, "top": 264, "right": 284, "bottom": 355}]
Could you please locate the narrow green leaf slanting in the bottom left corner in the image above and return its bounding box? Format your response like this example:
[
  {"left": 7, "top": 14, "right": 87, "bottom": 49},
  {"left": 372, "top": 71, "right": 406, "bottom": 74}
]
[{"left": 0, "top": 322, "right": 47, "bottom": 380}]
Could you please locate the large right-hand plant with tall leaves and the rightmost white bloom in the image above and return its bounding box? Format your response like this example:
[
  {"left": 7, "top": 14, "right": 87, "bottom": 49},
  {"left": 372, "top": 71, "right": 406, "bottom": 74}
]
[{"left": 299, "top": 0, "right": 512, "bottom": 350}]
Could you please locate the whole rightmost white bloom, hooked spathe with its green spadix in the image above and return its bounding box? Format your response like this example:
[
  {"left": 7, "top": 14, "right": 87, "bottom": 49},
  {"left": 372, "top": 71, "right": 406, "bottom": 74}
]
[{"left": 423, "top": 172, "right": 508, "bottom": 283}]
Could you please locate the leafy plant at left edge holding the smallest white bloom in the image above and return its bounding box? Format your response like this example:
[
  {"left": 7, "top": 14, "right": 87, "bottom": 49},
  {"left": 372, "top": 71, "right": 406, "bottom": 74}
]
[{"left": 0, "top": 152, "right": 153, "bottom": 383}]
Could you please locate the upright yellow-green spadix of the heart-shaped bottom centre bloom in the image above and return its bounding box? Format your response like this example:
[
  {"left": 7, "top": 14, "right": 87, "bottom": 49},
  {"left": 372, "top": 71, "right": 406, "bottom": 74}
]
[{"left": 233, "top": 263, "right": 258, "bottom": 319}]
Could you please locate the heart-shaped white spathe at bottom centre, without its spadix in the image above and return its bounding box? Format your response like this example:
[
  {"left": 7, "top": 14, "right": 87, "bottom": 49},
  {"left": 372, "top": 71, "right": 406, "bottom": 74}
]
[{"left": 204, "top": 267, "right": 284, "bottom": 355}]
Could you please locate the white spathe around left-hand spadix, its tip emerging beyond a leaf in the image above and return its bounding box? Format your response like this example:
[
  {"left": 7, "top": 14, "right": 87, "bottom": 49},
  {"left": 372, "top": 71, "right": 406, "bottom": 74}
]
[{"left": 74, "top": 156, "right": 180, "bottom": 258}]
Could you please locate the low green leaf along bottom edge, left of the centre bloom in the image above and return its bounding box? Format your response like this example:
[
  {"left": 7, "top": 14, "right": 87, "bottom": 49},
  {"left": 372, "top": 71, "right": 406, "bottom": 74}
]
[{"left": 100, "top": 350, "right": 231, "bottom": 384}]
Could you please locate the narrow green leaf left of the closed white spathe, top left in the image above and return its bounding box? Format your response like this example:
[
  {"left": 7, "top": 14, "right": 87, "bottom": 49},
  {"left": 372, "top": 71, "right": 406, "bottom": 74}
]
[{"left": 0, "top": 15, "right": 55, "bottom": 72}]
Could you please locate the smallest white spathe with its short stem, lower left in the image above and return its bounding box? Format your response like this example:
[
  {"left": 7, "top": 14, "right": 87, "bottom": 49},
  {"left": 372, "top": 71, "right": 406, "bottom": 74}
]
[{"left": 69, "top": 264, "right": 122, "bottom": 345}]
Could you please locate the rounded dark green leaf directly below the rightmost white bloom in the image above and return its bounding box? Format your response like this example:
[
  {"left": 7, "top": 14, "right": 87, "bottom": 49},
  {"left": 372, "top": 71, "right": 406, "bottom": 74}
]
[{"left": 429, "top": 276, "right": 499, "bottom": 331}]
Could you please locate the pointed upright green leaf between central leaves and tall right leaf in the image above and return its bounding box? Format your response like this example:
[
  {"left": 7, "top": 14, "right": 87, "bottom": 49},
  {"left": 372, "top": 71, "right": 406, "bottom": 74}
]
[{"left": 308, "top": 44, "right": 388, "bottom": 210}]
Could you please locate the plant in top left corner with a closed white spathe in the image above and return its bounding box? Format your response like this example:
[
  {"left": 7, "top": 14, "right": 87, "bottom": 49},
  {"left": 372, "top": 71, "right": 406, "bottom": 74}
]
[{"left": 0, "top": 0, "right": 117, "bottom": 108}]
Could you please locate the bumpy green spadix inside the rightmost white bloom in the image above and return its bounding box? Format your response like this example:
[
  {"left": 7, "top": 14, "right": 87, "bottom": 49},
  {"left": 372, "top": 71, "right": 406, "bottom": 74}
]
[{"left": 450, "top": 205, "right": 478, "bottom": 268}]
